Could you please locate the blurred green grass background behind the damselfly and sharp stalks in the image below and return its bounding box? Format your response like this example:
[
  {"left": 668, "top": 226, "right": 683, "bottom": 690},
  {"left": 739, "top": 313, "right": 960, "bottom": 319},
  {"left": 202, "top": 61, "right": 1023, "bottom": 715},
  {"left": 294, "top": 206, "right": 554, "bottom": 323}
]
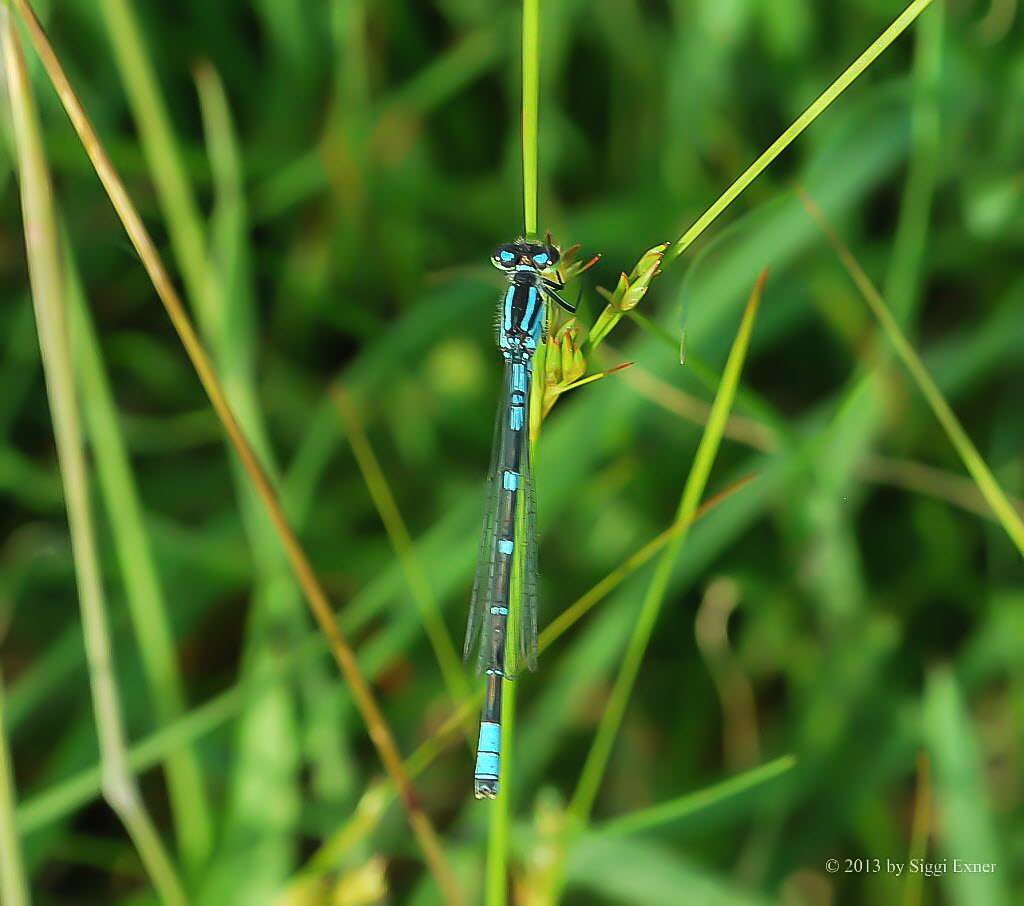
[{"left": 0, "top": 0, "right": 1024, "bottom": 906}]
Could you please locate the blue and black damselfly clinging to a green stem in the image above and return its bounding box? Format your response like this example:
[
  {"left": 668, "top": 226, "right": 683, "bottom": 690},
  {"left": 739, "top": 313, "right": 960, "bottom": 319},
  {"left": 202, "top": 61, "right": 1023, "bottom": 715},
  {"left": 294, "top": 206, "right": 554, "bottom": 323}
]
[{"left": 463, "top": 238, "right": 575, "bottom": 799}]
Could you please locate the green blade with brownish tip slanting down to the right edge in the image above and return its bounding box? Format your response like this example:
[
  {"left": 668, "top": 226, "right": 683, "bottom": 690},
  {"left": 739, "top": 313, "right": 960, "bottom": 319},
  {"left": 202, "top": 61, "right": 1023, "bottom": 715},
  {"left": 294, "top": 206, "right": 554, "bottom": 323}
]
[{"left": 799, "top": 190, "right": 1024, "bottom": 556}]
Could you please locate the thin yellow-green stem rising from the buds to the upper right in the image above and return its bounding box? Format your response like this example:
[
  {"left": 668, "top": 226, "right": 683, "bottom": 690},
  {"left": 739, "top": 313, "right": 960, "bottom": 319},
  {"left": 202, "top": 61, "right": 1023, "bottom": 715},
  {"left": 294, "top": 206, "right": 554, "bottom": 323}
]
[{"left": 665, "top": 0, "right": 932, "bottom": 264}]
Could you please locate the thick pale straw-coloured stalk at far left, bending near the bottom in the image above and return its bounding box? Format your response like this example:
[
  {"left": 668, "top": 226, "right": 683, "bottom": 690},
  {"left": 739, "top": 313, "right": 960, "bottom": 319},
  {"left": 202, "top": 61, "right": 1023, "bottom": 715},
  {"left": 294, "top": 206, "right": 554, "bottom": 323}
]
[{"left": 0, "top": 8, "right": 186, "bottom": 906}]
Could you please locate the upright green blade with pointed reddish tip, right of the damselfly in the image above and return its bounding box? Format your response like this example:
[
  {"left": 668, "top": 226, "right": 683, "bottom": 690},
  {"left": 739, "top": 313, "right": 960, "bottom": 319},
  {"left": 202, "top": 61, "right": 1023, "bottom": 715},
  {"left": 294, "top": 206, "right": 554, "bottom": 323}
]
[{"left": 569, "top": 273, "right": 766, "bottom": 826}]
